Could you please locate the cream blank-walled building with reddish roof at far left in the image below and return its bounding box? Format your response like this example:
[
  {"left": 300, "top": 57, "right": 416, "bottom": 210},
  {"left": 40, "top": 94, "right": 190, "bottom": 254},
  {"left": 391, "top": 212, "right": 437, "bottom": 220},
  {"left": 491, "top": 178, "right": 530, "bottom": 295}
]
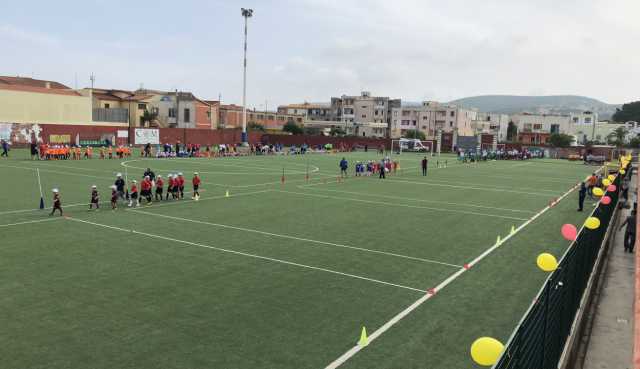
[{"left": 0, "top": 76, "right": 92, "bottom": 124}]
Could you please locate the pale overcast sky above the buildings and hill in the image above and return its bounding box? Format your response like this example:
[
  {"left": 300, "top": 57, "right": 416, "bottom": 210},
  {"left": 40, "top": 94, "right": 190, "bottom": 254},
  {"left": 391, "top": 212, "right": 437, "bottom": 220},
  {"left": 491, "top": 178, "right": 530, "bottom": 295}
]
[{"left": 0, "top": 0, "right": 640, "bottom": 109}]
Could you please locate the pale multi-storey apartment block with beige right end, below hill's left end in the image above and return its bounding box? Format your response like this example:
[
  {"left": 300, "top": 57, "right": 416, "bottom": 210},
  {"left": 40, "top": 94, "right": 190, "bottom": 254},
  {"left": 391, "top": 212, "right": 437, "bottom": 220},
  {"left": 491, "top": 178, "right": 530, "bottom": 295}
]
[{"left": 391, "top": 101, "right": 478, "bottom": 139}]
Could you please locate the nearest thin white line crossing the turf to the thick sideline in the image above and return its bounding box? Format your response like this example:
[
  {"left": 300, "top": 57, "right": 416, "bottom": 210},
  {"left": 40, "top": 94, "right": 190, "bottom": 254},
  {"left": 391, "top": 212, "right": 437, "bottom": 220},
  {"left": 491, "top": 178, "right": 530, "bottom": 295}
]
[{"left": 67, "top": 218, "right": 426, "bottom": 293}]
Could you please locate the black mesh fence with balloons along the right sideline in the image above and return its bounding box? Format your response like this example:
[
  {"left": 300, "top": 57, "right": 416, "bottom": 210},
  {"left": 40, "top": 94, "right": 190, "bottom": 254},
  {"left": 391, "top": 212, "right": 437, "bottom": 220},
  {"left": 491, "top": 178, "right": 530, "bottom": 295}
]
[{"left": 494, "top": 175, "right": 623, "bottom": 369}]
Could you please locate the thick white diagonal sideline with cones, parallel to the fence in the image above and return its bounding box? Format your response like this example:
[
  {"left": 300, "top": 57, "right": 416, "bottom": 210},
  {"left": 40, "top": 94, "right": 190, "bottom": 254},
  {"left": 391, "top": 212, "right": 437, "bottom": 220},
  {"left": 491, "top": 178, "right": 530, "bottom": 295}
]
[{"left": 325, "top": 174, "right": 592, "bottom": 369}]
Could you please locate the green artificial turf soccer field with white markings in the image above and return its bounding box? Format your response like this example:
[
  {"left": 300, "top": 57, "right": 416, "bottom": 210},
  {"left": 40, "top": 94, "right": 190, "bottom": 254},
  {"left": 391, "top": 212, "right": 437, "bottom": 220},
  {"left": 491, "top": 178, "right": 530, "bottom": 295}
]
[{"left": 0, "top": 150, "right": 594, "bottom": 369}]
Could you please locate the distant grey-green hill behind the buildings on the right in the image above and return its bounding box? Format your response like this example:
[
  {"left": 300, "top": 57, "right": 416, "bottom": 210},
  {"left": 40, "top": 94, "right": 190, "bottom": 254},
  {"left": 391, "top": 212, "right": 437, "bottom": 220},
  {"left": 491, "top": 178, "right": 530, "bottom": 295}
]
[{"left": 451, "top": 95, "right": 620, "bottom": 119}]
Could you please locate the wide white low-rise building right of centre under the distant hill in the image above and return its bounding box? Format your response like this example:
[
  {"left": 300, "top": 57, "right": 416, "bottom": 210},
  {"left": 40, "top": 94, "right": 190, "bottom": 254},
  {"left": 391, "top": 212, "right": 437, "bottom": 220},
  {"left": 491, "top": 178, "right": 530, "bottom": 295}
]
[{"left": 511, "top": 113, "right": 573, "bottom": 145}]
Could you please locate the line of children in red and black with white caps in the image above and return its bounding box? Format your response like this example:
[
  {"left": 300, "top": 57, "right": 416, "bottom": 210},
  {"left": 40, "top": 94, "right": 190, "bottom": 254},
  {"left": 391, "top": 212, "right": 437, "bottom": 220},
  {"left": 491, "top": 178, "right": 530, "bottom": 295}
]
[{"left": 50, "top": 169, "right": 202, "bottom": 216}]
